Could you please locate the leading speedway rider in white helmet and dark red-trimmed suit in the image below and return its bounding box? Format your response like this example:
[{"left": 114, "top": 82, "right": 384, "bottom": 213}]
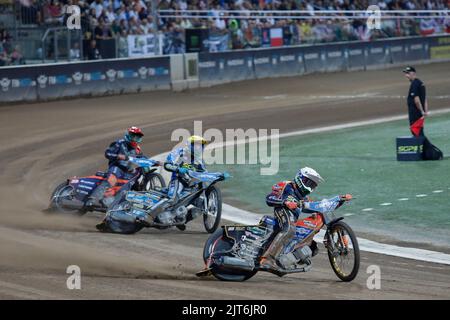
[{"left": 260, "top": 167, "right": 324, "bottom": 270}]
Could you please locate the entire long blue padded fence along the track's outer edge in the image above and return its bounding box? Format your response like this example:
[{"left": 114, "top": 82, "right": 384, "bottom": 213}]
[{"left": 0, "top": 35, "right": 450, "bottom": 104}]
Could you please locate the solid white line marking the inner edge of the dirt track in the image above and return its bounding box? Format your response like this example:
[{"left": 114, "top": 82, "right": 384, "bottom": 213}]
[{"left": 154, "top": 108, "right": 450, "bottom": 265}]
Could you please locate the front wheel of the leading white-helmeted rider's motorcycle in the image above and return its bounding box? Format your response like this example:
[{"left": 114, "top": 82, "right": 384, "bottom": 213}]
[{"left": 327, "top": 221, "right": 360, "bottom": 282}]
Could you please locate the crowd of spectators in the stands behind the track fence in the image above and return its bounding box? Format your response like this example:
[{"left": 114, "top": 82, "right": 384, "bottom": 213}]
[{"left": 6, "top": 0, "right": 450, "bottom": 59}]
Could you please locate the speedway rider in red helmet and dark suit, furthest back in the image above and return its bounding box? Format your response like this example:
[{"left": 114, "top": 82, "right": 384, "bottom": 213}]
[{"left": 86, "top": 126, "right": 144, "bottom": 207}]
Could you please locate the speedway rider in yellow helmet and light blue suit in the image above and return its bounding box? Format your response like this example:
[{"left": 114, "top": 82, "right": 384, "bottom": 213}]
[{"left": 164, "top": 135, "right": 208, "bottom": 203}]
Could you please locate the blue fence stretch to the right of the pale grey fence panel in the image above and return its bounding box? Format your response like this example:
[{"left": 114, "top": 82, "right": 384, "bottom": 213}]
[{"left": 199, "top": 35, "right": 450, "bottom": 86}]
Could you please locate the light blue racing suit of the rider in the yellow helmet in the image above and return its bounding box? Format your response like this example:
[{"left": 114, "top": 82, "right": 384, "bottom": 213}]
[{"left": 164, "top": 146, "right": 206, "bottom": 203}]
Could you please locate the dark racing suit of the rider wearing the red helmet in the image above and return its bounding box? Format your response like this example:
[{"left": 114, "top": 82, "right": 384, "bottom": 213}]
[{"left": 87, "top": 139, "right": 142, "bottom": 206}]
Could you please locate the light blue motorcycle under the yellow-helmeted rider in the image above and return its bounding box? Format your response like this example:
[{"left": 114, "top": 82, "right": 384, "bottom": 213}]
[{"left": 104, "top": 170, "right": 229, "bottom": 234}]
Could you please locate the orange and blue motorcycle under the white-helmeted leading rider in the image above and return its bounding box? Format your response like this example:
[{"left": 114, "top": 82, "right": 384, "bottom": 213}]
[{"left": 196, "top": 195, "right": 360, "bottom": 282}]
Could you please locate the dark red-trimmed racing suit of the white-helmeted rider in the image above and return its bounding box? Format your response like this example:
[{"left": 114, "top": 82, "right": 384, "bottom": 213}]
[{"left": 261, "top": 181, "right": 309, "bottom": 267}]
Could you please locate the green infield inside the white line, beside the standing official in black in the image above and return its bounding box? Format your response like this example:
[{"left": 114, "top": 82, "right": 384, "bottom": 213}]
[{"left": 209, "top": 114, "right": 450, "bottom": 245}]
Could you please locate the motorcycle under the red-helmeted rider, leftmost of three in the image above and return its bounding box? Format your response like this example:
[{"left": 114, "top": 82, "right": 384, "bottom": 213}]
[{"left": 47, "top": 156, "right": 166, "bottom": 215}]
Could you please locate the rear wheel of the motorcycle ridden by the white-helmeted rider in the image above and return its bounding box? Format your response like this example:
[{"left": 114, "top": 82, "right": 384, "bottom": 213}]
[{"left": 203, "top": 228, "right": 258, "bottom": 282}]
